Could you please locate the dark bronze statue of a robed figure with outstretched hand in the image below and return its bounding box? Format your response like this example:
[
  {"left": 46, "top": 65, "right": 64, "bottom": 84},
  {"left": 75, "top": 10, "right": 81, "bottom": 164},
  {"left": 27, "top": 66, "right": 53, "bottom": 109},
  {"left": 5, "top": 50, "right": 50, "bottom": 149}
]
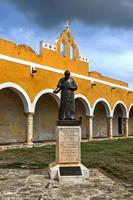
[{"left": 53, "top": 70, "right": 77, "bottom": 120}]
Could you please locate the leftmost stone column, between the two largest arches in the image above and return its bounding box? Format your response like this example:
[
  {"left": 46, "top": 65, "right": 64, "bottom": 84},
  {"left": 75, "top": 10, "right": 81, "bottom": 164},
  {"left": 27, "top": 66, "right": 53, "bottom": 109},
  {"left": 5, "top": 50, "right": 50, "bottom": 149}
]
[{"left": 26, "top": 113, "right": 33, "bottom": 144}]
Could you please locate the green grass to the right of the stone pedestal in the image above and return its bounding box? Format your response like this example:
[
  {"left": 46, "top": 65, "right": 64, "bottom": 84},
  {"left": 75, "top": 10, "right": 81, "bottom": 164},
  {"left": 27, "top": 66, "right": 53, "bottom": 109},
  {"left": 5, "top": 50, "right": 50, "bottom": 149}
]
[{"left": 82, "top": 139, "right": 133, "bottom": 183}]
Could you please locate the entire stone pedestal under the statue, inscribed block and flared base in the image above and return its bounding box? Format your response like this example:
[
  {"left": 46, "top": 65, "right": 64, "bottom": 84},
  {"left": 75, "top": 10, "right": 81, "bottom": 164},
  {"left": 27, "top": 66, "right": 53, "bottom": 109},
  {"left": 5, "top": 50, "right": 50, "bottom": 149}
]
[{"left": 49, "top": 126, "right": 89, "bottom": 183}]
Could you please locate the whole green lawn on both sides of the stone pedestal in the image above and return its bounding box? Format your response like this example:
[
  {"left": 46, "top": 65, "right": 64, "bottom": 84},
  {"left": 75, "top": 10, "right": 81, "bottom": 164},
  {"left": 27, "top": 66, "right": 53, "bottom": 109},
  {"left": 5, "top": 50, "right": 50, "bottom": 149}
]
[{"left": 0, "top": 139, "right": 133, "bottom": 183}]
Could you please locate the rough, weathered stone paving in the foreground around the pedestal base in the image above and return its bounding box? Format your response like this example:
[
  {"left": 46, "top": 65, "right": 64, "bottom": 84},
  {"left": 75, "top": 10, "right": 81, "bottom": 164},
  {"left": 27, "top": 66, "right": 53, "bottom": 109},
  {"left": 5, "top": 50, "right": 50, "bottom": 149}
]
[{"left": 0, "top": 169, "right": 133, "bottom": 200}]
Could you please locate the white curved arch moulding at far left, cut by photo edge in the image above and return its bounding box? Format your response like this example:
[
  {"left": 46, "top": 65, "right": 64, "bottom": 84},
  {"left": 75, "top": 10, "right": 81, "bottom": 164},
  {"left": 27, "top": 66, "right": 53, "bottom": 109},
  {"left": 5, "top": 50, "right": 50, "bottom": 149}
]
[{"left": 0, "top": 82, "right": 31, "bottom": 112}]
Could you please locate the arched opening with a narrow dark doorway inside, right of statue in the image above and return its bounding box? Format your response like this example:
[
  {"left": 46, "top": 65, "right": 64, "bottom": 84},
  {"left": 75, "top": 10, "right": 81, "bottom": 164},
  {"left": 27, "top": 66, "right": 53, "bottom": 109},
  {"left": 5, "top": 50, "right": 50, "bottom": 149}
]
[{"left": 113, "top": 103, "right": 127, "bottom": 137}]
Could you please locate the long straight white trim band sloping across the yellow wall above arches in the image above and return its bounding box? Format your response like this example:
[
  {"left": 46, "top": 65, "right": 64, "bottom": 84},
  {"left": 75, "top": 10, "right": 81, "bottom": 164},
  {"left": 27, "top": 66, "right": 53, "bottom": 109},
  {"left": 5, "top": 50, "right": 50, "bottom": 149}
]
[{"left": 0, "top": 54, "right": 133, "bottom": 91}]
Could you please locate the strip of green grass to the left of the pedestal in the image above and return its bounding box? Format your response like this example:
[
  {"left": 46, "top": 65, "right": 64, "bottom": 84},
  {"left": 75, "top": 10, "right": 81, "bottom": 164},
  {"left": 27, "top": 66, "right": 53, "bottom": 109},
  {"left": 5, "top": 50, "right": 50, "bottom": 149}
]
[{"left": 0, "top": 145, "right": 55, "bottom": 169}]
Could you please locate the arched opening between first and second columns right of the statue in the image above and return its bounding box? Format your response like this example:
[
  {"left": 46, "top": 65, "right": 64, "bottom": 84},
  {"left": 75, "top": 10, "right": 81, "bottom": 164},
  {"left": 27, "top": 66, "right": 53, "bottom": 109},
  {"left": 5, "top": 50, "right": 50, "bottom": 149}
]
[{"left": 93, "top": 101, "right": 110, "bottom": 138}]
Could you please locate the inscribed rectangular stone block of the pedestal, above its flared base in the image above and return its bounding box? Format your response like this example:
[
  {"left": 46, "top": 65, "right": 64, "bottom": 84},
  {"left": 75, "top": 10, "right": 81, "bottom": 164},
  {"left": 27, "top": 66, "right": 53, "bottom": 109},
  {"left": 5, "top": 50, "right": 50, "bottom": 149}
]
[{"left": 56, "top": 126, "right": 81, "bottom": 164}]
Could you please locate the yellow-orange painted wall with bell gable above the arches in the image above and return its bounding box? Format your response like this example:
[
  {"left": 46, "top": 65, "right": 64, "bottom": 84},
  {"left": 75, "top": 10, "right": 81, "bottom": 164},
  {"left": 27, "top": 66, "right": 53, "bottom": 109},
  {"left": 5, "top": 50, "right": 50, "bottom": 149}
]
[{"left": 0, "top": 28, "right": 133, "bottom": 112}]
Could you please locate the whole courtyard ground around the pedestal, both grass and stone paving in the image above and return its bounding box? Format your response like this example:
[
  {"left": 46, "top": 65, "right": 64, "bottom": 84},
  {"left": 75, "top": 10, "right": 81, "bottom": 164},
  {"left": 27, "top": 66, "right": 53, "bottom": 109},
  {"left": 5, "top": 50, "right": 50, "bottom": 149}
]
[{"left": 0, "top": 138, "right": 133, "bottom": 200}]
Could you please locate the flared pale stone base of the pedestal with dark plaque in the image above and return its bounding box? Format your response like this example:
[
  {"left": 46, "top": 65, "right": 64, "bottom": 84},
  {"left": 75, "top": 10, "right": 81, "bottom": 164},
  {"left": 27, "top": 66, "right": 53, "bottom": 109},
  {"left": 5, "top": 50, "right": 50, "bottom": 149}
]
[{"left": 49, "top": 163, "right": 89, "bottom": 183}]
